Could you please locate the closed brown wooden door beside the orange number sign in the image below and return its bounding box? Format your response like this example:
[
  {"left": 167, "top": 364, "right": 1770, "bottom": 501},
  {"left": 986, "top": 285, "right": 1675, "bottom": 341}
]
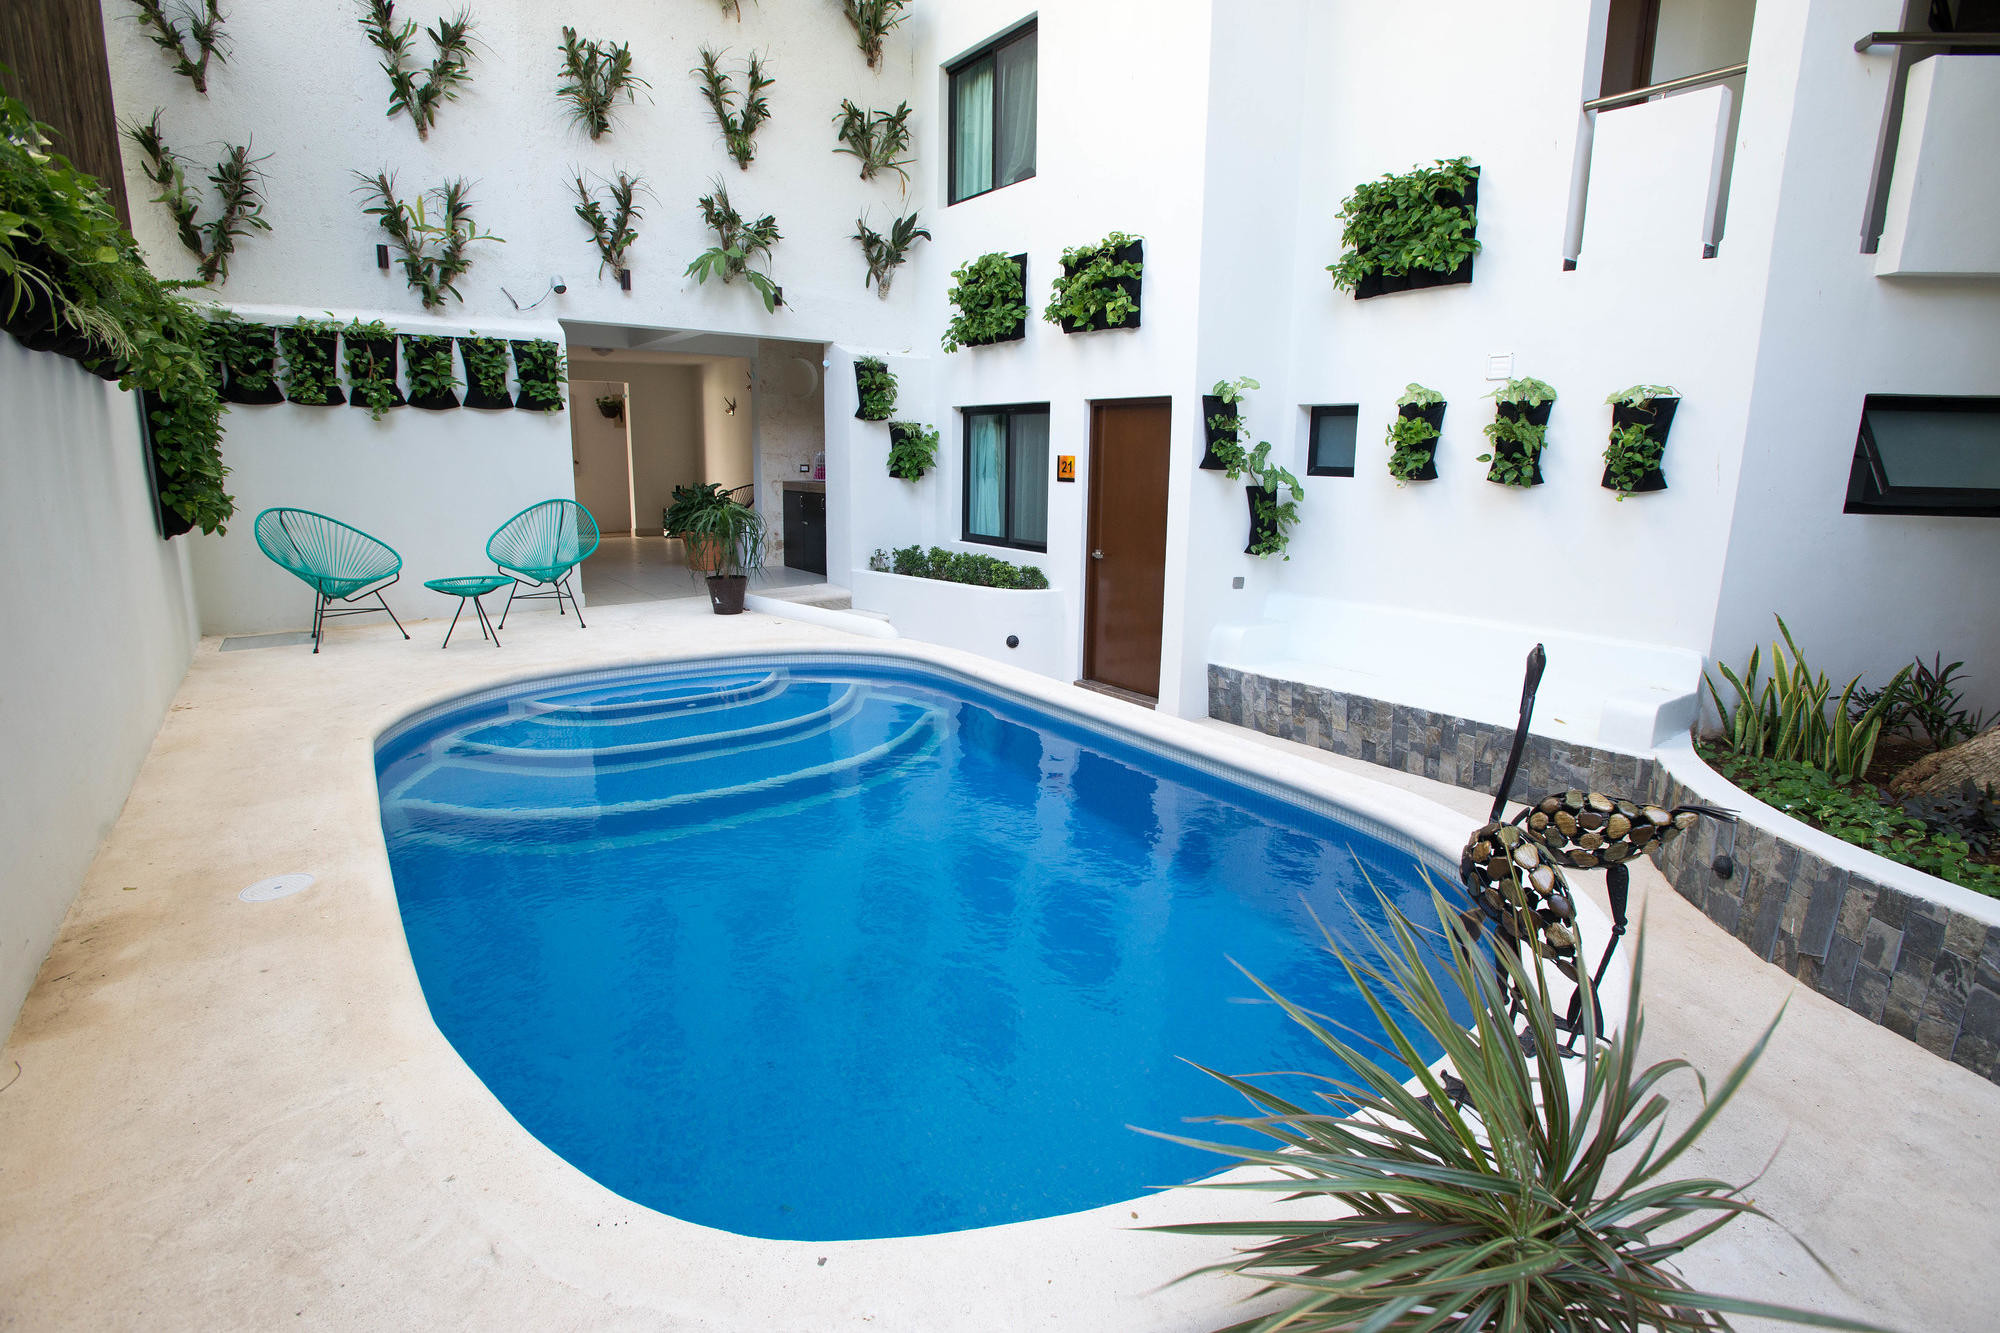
[{"left": 1084, "top": 398, "right": 1172, "bottom": 699}]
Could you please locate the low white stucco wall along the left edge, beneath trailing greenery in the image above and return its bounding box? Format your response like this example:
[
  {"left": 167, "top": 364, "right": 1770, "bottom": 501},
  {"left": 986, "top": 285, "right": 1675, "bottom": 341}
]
[{"left": 0, "top": 336, "right": 194, "bottom": 1031}]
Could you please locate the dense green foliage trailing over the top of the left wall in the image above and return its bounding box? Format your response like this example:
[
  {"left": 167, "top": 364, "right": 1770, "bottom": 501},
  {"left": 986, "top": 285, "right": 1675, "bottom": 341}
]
[{"left": 0, "top": 85, "right": 236, "bottom": 532}]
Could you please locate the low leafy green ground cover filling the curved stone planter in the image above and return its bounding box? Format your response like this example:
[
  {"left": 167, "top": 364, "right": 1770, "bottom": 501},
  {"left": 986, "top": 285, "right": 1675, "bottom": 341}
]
[{"left": 1702, "top": 745, "right": 2000, "bottom": 897}]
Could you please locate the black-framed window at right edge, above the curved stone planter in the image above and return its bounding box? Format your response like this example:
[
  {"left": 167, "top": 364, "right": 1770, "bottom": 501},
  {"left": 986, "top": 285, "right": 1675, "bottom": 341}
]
[{"left": 1846, "top": 394, "right": 2000, "bottom": 518}]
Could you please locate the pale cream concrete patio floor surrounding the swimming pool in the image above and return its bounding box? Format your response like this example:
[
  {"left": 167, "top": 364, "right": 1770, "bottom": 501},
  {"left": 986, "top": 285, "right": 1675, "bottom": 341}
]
[{"left": 0, "top": 598, "right": 2000, "bottom": 1333}]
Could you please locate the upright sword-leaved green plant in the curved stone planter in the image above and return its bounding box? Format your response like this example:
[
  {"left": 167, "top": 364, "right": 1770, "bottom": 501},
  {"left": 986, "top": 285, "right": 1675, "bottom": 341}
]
[{"left": 1702, "top": 616, "right": 1910, "bottom": 787}]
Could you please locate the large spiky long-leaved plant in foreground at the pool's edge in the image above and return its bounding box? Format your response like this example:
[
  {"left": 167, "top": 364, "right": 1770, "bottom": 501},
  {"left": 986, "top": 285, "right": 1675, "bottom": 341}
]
[{"left": 1148, "top": 893, "right": 1872, "bottom": 1333}]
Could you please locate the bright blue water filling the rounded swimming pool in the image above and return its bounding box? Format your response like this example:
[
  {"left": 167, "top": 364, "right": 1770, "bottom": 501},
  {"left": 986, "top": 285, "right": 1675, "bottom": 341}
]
[{"left": 378, "top": 658, "right": 1452, "bottom": 1241}]
